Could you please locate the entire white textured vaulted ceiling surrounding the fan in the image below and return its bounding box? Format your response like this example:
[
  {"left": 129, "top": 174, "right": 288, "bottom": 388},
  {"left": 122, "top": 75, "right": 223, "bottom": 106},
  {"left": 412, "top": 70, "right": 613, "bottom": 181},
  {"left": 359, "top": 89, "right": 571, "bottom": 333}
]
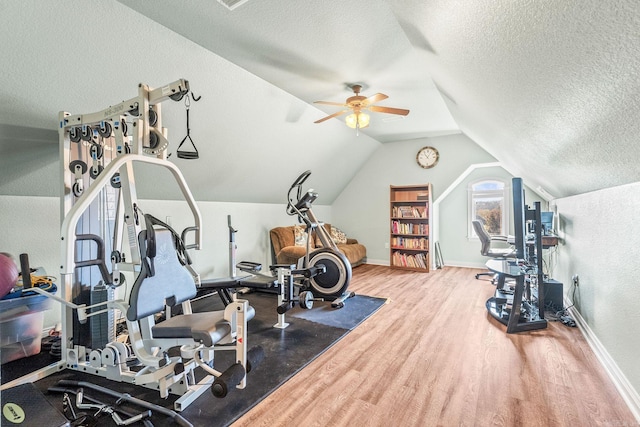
[{"left": 0, "top": 0, "right": 640, "bottom": 203}]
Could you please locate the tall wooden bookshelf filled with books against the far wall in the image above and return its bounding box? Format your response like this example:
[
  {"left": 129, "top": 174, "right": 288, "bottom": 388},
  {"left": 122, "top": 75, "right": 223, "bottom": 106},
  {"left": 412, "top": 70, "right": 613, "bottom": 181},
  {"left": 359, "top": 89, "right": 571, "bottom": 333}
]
[{"left": 389, "top": 184, "right": 431, "bottom": 273}]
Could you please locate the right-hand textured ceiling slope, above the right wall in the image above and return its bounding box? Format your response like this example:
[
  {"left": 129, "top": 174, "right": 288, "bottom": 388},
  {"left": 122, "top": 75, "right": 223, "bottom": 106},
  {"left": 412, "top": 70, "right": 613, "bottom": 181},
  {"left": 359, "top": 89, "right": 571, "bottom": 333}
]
[{"left": 393, "top": 0, "right": 640, "bottom": 197}]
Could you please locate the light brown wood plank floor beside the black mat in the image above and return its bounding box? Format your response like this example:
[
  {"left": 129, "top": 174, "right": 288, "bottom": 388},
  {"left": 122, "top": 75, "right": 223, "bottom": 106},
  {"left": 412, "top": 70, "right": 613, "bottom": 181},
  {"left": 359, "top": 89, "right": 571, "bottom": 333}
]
[{"left": 233, "top": 265, "right": 638, "bottom": 427}]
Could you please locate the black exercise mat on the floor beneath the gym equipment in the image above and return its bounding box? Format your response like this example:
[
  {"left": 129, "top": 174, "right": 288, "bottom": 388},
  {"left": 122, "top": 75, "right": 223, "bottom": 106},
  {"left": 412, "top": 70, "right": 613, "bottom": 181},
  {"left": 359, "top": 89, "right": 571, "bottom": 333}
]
[{"left": 1, "top": 293, "right": 386, "bottom": 426}]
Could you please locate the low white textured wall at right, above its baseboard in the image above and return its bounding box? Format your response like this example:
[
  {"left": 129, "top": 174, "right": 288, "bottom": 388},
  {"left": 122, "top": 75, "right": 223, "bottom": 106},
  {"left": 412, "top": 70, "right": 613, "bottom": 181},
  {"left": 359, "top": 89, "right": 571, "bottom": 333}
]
[{"left": 552, "top": 183, "right": 640, "bottom": 393}]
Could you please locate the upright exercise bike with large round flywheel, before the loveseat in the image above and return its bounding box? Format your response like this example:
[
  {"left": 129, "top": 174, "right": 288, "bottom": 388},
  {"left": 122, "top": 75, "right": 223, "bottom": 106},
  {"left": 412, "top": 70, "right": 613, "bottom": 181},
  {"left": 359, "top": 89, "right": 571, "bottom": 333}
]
[{"left": 287, "top": 171, "right": 355, "bottom": 308}]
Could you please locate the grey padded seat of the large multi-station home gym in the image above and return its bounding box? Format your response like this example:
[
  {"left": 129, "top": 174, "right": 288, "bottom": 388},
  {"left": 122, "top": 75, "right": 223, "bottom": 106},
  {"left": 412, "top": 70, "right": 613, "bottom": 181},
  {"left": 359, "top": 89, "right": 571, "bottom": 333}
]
[{"left": 151, "top": 306, "right": 256, "bottom": 347}]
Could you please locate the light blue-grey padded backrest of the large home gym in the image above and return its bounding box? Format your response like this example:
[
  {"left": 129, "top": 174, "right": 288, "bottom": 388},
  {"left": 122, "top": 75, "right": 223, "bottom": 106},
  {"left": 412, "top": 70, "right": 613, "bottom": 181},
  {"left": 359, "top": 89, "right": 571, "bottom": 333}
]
[{"left": 127, "top": 228, "right": 197, "bottom": 321}]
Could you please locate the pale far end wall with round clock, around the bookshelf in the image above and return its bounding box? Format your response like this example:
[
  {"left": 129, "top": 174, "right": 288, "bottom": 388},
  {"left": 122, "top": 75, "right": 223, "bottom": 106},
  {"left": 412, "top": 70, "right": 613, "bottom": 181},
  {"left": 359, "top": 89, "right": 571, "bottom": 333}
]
[{"left": 332, "top": 134, "right": 495, "bottom": 265}]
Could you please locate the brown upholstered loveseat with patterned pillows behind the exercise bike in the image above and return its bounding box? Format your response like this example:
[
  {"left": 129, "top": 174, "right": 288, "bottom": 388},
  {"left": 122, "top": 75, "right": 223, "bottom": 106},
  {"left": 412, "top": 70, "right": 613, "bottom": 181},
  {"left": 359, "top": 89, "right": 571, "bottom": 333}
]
[{"left": 269, "top": 224, "right": 367, "bottom": 267}]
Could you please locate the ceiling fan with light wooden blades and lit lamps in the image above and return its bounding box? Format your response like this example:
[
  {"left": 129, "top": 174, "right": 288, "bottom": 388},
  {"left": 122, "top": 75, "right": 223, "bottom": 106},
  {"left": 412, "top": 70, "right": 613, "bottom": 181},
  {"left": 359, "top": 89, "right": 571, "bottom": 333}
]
[{"left": 314, "top": 84, "right": 409, "bottom": 130}]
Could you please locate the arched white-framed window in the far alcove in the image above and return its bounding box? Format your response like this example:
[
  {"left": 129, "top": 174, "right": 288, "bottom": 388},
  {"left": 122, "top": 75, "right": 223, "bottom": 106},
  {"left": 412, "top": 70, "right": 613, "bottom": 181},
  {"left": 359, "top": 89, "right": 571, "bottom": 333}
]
[{"left": 469, "top": 180, "right": 509, "bottom": 238}]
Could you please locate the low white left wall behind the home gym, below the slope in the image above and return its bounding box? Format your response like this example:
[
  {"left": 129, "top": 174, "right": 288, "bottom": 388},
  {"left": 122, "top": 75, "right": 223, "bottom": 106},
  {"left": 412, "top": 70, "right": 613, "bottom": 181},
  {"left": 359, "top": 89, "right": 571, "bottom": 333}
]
[{"left": 0, "top": 195, "right": 331, "bottom": 329}]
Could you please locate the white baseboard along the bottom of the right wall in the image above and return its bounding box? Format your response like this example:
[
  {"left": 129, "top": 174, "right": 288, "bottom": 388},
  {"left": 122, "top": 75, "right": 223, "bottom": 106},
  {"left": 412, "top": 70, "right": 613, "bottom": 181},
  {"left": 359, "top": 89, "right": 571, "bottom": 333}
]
[{"left": 565, "top": 299, "right": 640, "bottom": 423}]
